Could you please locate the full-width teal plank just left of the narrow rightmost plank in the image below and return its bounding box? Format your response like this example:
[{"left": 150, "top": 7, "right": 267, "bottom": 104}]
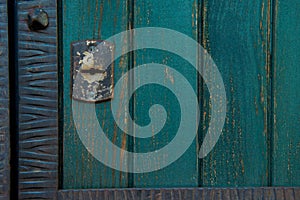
[{"left": 200, "top": 0, "right": 271, "bottom": 187}]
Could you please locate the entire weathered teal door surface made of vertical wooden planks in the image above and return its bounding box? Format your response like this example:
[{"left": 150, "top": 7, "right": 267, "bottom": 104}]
[{"left": 60, "top": 0, "right": 300, "bottom": 189}]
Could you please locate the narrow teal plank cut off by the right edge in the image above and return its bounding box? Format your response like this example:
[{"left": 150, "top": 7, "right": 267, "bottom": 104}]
[{"left": 272, "top": 0, "right": 300, "bottom": 186}]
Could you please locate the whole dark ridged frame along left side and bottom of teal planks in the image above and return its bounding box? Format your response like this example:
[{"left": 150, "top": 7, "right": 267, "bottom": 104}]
[{"left": 0, "top": 0, "right": 300, "bottom": 199}]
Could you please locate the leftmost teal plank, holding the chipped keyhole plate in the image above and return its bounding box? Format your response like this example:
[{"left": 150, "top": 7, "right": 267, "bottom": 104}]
[{"left": 62, "top": 0, "right": 129, "bottom": 189}]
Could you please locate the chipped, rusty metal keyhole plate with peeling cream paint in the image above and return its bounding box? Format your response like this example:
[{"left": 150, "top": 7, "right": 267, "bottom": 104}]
[{"left": 71, "top": 40, "right": 114, "bottom": 102}]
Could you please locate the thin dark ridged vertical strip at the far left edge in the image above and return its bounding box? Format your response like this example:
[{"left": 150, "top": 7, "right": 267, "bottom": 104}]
[{"left": 0, "top": 0, "right": 10, "bottom": 199}]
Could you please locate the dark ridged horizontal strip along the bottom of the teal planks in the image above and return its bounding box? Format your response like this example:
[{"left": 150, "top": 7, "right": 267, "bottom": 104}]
[{"left": 58, "top": 188, "right": 300, "bottom": 200}]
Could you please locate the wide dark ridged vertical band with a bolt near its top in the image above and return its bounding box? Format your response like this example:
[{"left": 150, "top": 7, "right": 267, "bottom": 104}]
[{"left": 17, "top": 0, "right": 58, "bottom": 199}]
